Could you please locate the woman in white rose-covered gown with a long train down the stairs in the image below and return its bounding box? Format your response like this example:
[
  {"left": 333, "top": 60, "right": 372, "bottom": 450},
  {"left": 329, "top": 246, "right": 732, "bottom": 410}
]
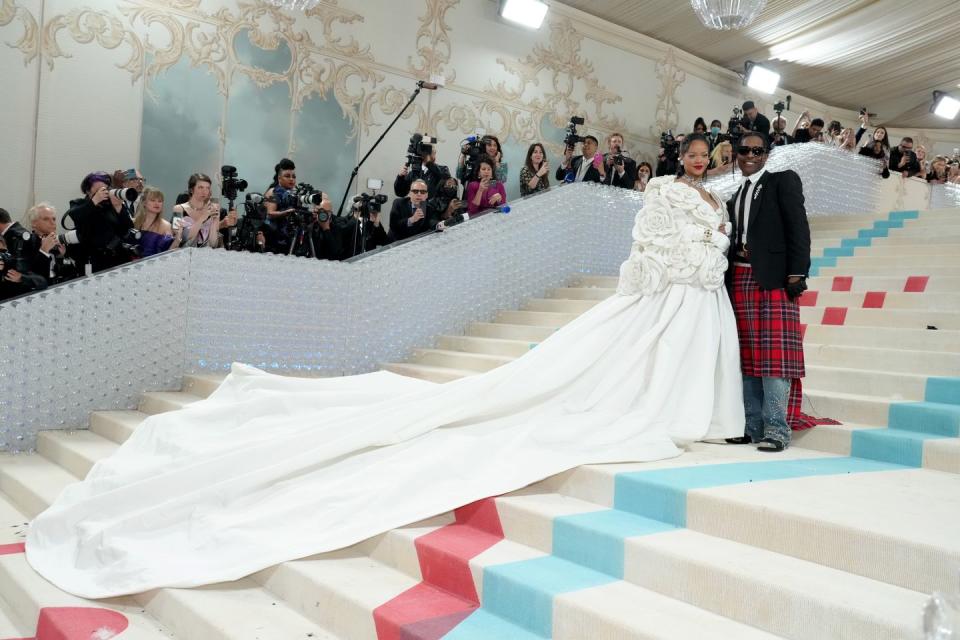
[{"left": 27, "top": 138, "right": 744, "bottom": 598}]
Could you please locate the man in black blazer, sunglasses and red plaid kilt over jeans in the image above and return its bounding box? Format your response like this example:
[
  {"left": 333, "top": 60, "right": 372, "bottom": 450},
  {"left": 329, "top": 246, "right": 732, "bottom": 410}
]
[{"left": 727, "top": 133, "right": 810, "bottom": 451}]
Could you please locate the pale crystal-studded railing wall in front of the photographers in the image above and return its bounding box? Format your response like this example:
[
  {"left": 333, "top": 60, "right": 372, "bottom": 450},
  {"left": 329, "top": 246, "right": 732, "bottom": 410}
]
[{"left": 0, "top": 144, "right": 928, "bottom": 450}]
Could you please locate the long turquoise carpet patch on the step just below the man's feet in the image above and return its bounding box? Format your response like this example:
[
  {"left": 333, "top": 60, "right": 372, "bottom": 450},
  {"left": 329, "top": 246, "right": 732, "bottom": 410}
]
[{"left": 613, "top": 458, "right": 902, "bottom": 527}]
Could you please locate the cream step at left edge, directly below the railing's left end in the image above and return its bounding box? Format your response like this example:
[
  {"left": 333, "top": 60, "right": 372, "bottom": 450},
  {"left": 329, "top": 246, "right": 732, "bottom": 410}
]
[{"left": 0, "top": 455, "right": 77, "bottom": 518}]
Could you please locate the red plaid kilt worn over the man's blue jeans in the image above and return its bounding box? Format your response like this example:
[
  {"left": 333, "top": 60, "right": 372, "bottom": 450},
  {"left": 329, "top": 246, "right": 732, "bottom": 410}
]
[{"left": 733, "top": 264, "right": 806, "bottom": 378}]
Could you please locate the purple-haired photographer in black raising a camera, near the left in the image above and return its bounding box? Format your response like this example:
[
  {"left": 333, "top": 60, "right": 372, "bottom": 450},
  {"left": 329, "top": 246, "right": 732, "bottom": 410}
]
[{"left": 64, "top": 172, "right": 138, "bottom": 273}]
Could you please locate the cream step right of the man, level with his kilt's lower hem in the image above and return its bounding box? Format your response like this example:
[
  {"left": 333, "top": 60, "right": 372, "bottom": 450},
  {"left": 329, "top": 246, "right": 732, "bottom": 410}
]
[{"left": 803, "top": 340, "right": 960, "bottom": 376}]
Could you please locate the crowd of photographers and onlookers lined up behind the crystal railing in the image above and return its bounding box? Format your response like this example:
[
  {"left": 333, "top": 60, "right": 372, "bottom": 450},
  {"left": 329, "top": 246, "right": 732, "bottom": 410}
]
[{"left": 0, "top": 101, "right": 960, "bottom": 300}]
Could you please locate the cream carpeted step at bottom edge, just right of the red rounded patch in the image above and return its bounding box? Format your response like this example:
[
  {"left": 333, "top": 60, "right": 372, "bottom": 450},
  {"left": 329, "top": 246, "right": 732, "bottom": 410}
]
[{"left": 135, "top": 579, "right": 336, "bottom": 640}]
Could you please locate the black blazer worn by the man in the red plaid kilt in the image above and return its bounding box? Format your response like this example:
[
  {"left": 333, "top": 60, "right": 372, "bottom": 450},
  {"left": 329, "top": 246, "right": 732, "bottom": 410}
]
[{"left": 727, "top": 170, "right": 810, "bottom": 290}]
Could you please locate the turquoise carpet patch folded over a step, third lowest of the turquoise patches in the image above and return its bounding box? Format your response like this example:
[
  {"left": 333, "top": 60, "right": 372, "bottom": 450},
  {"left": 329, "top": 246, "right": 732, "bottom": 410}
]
[{"left": 553, "top": 509, "right": 676, "bottom": 578}]
